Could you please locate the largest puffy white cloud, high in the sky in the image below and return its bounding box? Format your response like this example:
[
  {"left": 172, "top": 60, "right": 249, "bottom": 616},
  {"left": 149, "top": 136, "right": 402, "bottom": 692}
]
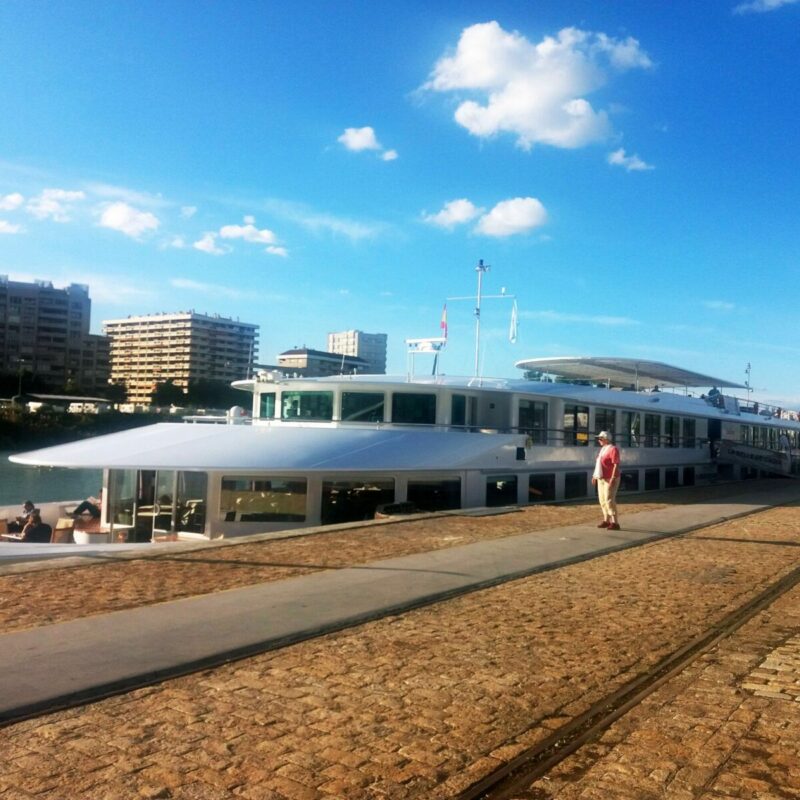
[{"left": 424, "top": 22, "right": 652, "bottom": 150}]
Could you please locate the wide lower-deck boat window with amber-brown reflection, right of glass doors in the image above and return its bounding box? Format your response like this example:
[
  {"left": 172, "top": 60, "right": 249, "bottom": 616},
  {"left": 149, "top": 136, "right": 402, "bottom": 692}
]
[{"left": 219, "top": 475, "right": 306, "bottom": 522}]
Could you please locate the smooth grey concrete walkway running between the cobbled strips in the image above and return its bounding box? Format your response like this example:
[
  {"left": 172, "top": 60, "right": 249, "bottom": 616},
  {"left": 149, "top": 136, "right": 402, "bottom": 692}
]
[{"left": 0, "top": 483, "right": 800, "bottom": 721}]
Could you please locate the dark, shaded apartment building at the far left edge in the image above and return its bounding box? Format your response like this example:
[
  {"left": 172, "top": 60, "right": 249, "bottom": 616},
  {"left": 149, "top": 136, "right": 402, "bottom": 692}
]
[{"left": 0, "top": 275, "right": 108, "bottom": 392}]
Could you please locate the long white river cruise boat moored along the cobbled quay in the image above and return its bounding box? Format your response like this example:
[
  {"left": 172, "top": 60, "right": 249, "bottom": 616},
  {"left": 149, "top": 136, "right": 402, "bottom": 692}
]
[{"left": 11, "top": 358, "right": 800, "bottom": 541}]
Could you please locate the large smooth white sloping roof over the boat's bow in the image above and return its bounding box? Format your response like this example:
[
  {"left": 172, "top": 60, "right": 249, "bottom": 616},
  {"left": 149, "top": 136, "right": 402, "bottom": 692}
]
[{"left": 10, "top": 423, "right": 519, "bottom": 473}]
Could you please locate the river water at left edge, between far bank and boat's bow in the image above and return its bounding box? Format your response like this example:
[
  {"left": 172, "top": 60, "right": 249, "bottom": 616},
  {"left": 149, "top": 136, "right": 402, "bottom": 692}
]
[{"left": 0, "top": 450, "right": 103, "bottom": 506}]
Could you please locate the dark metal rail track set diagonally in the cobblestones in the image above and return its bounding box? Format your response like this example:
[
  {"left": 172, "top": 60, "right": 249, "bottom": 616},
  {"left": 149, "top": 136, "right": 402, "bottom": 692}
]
[{"left": 457, "top": 567, "right": 800, "bottom": 800}]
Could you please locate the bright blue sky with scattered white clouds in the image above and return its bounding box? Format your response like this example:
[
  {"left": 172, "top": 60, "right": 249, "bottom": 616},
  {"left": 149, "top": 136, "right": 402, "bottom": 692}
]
[{"left": 0, "top": 0, "right": 800, "bottom": 407}]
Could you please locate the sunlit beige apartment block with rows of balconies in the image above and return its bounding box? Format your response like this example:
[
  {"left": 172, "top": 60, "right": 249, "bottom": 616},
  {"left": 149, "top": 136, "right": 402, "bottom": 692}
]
[{"left": 103, "top": 311, "right": 258, "bottom": 403}]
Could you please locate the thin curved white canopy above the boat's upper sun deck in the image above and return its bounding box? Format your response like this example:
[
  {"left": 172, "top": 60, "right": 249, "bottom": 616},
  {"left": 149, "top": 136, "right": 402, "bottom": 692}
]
[{"left": 516, "top": 356, "right": 747, "bottom": 389}]
